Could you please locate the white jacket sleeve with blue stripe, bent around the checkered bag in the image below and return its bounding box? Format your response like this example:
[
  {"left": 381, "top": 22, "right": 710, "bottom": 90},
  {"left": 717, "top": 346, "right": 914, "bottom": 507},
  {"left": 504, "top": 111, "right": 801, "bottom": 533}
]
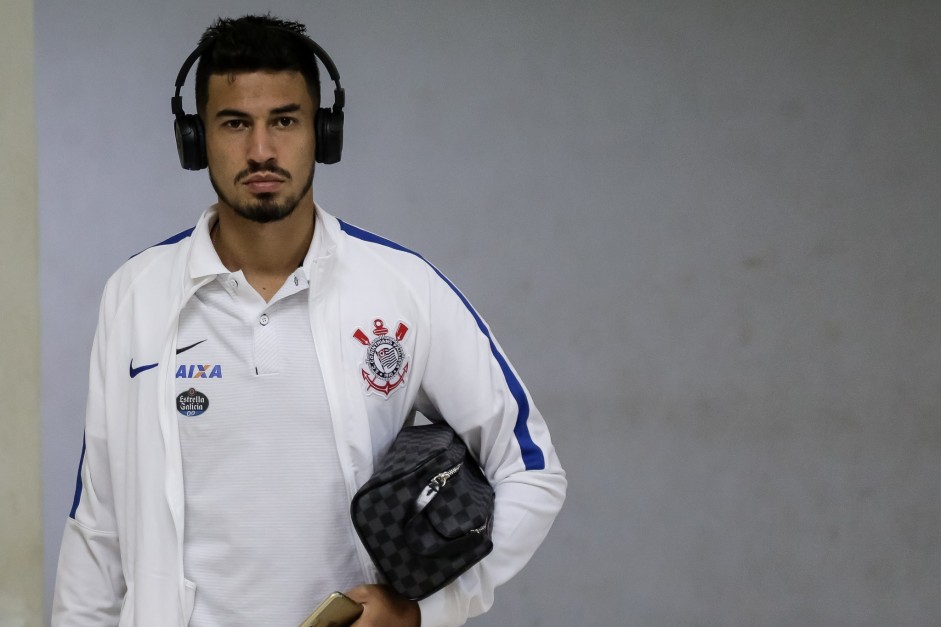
[{"left": 417, "top": 275, "right": 567, "bottom": 627}]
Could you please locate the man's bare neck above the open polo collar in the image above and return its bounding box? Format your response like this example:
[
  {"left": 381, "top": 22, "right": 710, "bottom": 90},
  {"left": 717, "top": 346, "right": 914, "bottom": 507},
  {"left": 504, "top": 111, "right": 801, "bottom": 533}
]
[{"left": 212, "top": 197, "right": 314, "bottom": 301}]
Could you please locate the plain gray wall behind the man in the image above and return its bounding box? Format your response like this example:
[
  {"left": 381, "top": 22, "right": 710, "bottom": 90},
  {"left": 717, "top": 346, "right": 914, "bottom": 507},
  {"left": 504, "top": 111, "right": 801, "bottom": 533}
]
[{"left": 36, "top": 0, "right": 941, "bottom": 627}]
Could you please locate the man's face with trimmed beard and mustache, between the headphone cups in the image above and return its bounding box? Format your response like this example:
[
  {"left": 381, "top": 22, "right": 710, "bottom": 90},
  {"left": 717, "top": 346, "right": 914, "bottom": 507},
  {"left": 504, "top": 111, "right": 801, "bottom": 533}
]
[{"left": 203, "top": 72, "right": 316, "bottom": 222}]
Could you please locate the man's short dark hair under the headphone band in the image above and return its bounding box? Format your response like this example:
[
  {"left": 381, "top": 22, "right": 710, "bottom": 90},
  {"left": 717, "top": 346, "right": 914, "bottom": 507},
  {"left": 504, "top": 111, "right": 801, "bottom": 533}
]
[{"left": 196, "top": 13, "right": 320, "bottom": 114}]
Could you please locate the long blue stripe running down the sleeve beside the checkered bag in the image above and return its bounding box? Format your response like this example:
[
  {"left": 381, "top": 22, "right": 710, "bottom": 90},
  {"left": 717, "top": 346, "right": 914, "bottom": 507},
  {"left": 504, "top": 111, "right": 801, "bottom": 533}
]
[{"left": 339, "top": 220, "right": 546, "bottom": 470}]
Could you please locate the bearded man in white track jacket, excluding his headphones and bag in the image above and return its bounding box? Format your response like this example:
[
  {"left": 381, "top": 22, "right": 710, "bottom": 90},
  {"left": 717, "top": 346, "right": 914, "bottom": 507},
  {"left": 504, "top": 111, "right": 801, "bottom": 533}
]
[{"left": 53, "top": 16, "right": 566, "bottom": 627}]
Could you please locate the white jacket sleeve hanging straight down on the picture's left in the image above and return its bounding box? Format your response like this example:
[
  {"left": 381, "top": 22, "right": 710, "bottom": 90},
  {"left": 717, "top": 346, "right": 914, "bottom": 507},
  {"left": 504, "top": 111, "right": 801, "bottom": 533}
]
[{"left": 52, "top": 290, "right": 126, "bottom": 627}]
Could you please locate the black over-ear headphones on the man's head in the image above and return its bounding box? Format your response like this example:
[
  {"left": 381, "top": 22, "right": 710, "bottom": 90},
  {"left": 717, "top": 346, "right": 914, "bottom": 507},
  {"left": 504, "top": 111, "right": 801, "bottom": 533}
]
[{"left": 170, "top": 27, "right": 346, "bottom": 170}]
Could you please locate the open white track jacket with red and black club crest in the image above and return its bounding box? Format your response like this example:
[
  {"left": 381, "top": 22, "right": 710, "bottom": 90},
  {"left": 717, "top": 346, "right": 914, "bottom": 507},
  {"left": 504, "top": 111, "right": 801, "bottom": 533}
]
[{"left": 52, "top": 207, "right": 566, "bottom": 627}]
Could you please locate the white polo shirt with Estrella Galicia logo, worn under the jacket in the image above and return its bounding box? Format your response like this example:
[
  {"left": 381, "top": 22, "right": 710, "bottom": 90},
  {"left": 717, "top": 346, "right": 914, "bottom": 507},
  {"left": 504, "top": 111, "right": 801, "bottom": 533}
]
[{"left": 173, "top": 213, "right": 365, "bottom": 627}]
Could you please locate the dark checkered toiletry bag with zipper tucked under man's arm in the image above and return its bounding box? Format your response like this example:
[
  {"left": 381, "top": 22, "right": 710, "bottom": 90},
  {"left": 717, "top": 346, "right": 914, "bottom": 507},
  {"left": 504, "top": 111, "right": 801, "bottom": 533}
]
[{"left": 350, "top": 423, "right": 494, "bottom": 600}]
